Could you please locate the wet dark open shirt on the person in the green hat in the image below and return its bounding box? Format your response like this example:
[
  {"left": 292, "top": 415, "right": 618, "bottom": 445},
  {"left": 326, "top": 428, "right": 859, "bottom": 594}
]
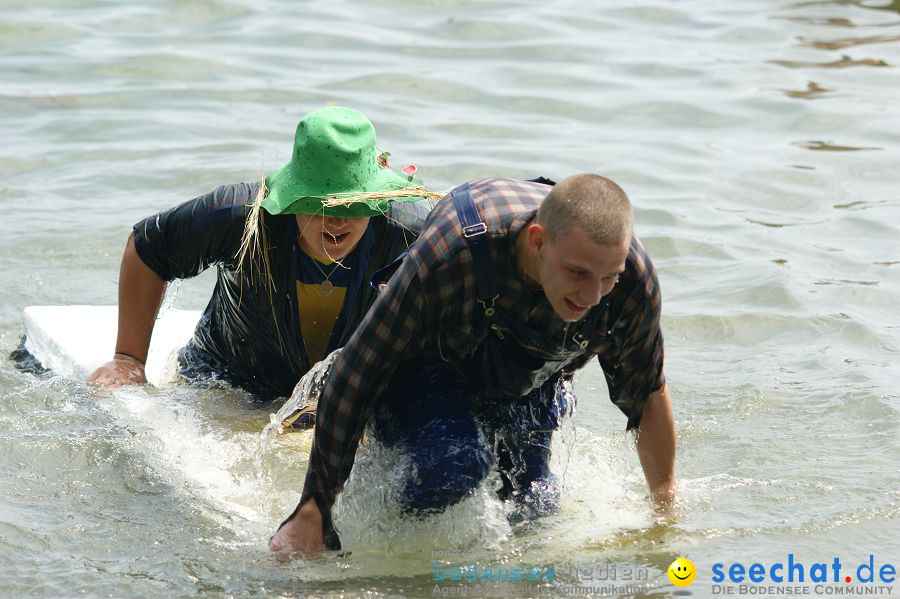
[{"left": 134, "top": 183, "right": 427, "bottom": 399}]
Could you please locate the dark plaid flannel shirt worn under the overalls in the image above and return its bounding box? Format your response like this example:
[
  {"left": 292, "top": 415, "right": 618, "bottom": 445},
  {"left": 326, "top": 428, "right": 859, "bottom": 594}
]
[{"left": 300, "top": 178, "right": 664, "bottom": 528}]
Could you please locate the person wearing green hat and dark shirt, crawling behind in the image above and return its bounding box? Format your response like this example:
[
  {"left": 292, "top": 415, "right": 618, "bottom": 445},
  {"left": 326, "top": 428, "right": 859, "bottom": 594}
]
[{"left": 90, "top": 107, "right": 435, "bottom": 399}]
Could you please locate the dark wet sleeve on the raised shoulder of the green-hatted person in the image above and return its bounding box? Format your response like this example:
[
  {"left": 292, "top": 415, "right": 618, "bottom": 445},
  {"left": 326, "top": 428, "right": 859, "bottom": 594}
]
[{"left": 133, "top": 185, "right": 248, "bottom": 281}]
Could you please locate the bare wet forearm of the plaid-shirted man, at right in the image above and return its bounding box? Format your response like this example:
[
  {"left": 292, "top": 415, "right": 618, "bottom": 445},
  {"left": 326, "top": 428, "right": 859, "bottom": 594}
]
[{"left": 637, "top": 384, "right": 676, "bottom": 504}]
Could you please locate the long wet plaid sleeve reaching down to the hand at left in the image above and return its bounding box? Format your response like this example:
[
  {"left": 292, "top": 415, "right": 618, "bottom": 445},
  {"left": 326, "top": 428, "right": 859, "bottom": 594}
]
[{"left": 300, "top": 248, "right": 433, "bottom": 535}]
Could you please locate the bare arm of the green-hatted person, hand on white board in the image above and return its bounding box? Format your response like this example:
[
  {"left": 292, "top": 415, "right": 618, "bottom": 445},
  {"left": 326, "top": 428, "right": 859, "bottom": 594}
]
[{"left": 88, "top": 233, "right": 166, "bottom": 387}]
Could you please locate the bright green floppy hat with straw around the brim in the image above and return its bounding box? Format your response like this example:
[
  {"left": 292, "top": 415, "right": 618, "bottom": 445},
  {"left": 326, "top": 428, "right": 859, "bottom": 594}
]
[{"left": 262, "top": 106, "right": 428, "bottom": 218}]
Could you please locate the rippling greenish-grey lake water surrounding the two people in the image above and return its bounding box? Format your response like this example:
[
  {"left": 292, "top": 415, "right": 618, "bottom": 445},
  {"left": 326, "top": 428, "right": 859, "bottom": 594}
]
[{"left": 0, "top": 0, "right": 900, "bottom": 597}]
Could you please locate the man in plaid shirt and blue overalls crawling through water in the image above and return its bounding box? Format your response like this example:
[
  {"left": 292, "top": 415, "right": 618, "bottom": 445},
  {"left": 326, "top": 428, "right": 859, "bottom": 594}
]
[{"left": 270, "top": 175, "right": 675, "bottom": 554}]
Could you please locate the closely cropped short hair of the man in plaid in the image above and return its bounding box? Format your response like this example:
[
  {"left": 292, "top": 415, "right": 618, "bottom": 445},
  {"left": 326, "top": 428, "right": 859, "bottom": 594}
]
[{"left": 536, "top": 174, "right": 634, "bottom": 245}]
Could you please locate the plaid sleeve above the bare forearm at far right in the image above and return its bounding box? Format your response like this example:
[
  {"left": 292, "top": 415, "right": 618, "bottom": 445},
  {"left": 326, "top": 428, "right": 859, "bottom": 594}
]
[{"left": 598, "top": 256, "right": 665, "bottom": 430}]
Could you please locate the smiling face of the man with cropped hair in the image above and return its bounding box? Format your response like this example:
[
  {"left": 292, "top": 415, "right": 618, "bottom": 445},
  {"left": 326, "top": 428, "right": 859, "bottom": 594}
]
[{"left": 528, "top": 224, "right": 630, "bottom": 322}]
